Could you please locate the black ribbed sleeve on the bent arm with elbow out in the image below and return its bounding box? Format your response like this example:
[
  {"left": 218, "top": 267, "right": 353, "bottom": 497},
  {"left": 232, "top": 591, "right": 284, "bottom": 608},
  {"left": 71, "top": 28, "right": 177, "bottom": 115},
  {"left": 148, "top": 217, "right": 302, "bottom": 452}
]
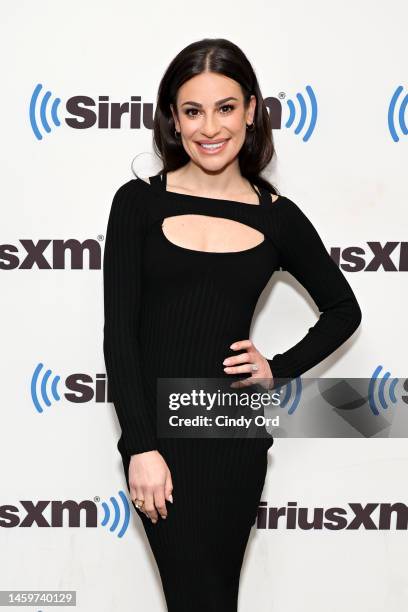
[{"left": 268, "top": 198, "right": 362, "bottom": 378}]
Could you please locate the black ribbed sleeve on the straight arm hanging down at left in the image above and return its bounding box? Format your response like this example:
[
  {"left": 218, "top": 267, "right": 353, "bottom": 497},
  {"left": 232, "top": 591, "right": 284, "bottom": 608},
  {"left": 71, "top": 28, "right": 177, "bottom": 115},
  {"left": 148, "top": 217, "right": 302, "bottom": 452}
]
[{"left": 103, "top": 181, "right": 157, "bottom": 455}]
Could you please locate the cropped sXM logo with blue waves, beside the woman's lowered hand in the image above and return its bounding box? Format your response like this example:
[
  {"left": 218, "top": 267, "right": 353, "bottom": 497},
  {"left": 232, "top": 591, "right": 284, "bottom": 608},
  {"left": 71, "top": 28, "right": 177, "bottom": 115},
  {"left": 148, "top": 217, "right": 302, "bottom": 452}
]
[{"left": 0, "top": 490, "right": 130, "bottom": 538}]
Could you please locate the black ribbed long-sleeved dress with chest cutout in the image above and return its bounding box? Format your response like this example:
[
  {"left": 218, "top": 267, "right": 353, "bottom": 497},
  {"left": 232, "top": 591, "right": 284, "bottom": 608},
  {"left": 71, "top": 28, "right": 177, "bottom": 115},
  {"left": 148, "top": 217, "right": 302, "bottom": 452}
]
[{"left": 103, "top": 173, "right": 361, "bottom": 612}]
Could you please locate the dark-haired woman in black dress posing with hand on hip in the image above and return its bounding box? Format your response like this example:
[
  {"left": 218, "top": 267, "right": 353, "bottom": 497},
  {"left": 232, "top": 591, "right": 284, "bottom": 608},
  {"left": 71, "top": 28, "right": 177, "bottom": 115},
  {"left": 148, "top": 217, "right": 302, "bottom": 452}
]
[{"left": 104, "top": 39, "right": 361, "bottom": 612}]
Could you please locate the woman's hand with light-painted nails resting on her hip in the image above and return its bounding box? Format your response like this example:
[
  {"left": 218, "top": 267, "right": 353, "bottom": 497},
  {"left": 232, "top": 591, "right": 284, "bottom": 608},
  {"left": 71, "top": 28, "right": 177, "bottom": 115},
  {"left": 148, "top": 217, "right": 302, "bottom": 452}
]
[{"left": 223, "top": 340, "right": 273, "bottom": 390}]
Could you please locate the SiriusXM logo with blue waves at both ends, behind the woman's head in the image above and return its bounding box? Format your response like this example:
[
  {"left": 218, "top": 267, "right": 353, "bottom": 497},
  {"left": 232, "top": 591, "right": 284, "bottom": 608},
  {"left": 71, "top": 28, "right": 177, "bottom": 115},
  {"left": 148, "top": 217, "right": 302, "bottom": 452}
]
[{"left": 29, "top": 83, "right": 317, "bottom": 142}]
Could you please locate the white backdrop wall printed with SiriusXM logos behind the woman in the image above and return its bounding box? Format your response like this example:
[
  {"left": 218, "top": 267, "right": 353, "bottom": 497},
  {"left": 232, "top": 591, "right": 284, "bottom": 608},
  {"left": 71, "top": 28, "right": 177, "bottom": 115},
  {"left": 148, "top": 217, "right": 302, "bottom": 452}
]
[{"left": 0, "top": 0, "right": 408, "bottom": 612}]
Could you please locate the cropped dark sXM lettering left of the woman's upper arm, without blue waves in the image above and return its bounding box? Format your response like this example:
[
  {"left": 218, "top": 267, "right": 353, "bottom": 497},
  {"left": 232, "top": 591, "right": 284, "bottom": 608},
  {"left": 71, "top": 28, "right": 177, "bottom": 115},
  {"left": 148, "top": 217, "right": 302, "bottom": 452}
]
[{"left": 0, "top": 236, "right": 103, "bottom": 270}]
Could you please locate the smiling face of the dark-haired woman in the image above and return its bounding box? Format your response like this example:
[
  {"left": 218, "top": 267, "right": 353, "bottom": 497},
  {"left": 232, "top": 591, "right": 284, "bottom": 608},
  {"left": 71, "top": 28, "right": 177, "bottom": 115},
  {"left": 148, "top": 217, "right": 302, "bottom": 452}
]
[{"left": 171, "top": 72, "right": 256, "bottom": 170}]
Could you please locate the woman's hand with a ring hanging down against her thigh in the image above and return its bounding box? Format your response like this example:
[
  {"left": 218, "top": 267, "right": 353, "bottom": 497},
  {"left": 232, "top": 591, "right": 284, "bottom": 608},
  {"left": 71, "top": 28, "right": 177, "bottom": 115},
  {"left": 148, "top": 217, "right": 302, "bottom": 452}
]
[{"left": 129, "top": 450, "right": 173, "bottom": 523}]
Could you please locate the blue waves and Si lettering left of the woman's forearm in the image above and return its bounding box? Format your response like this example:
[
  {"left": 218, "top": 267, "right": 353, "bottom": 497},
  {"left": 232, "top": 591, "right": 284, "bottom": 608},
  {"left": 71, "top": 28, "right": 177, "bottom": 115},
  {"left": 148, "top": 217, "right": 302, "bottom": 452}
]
[{"left": 30, "top": 363, "right": 110, "bottom": 413}]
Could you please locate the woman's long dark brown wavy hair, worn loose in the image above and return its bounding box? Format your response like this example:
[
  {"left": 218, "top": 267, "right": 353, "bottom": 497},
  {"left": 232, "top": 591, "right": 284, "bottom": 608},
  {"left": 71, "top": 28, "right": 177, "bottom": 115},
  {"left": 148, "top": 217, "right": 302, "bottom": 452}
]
[{"left": 142, "top": 38, "right": 279, "bottom": 195}]
